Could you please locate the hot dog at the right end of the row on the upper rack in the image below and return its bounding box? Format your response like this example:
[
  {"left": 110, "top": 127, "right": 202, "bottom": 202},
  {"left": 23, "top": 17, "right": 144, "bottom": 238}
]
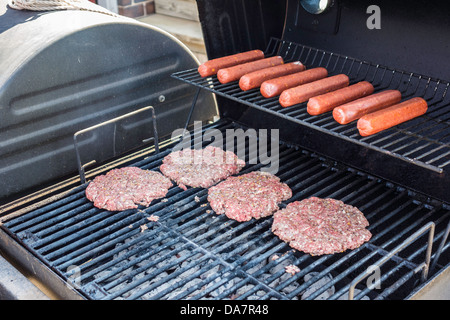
[{"left": 356, "top": 97, "right": 428, "bottom": 136}]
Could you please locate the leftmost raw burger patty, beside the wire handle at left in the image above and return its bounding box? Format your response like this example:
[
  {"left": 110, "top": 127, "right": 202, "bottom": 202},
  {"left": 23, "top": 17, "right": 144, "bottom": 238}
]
[{"left": 86, "top": 167, "right": 172, "bottom": 211}]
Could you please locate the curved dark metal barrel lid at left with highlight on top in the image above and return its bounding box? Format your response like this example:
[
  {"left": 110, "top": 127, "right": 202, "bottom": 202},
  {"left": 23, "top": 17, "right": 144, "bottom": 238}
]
[{"left": 0, "top": 1, "right": 217, "bottom": 198}]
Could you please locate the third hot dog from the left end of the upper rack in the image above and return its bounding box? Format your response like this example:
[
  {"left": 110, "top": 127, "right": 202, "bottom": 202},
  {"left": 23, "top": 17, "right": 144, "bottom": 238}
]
[{"left": 239, "top": 61, "right": 306, "bottom": 91}]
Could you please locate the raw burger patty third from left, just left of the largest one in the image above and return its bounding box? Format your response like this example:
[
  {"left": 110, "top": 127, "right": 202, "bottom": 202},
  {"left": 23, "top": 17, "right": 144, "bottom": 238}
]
[{"left": 208, "top": 171, "right": 292, "bottom": 221}]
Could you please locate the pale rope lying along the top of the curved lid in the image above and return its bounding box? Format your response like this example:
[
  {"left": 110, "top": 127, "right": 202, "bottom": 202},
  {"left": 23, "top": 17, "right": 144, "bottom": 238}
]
[{"left": 8, "top": 0, "right": 119, "bottom": 17}]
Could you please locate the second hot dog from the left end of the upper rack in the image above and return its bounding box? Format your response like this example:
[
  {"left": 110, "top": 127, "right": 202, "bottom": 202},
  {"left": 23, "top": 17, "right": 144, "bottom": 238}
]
[{"left": 217, "top": 56, "right": 284, "bottom": 83}]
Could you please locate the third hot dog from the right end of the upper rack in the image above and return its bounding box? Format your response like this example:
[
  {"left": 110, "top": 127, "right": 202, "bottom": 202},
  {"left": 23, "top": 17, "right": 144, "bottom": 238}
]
[{"left": 306, "top": 81, "right": 374, "bottom": 116}]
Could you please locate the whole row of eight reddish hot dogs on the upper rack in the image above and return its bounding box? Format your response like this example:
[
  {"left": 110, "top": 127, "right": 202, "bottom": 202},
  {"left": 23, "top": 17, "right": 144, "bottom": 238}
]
[{"left": 198, "top": 50, "right": 428, "bottom": 136}]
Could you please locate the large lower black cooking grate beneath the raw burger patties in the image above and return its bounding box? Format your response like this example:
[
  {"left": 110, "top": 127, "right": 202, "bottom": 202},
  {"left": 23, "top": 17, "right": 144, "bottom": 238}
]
[{"left": 2, "top": 120, "right": 450, "bottom": 299}]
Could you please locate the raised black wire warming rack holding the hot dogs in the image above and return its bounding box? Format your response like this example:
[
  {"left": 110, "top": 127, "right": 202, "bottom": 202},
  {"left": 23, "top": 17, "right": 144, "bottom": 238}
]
[{"left": 172, "top": 38, "right": 450, "bottom": 173}]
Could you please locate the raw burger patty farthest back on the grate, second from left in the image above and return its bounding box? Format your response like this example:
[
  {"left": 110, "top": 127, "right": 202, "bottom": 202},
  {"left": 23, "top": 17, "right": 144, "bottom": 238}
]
[{"left": 159, "top": 146, "right": 245, "bottom": 190}]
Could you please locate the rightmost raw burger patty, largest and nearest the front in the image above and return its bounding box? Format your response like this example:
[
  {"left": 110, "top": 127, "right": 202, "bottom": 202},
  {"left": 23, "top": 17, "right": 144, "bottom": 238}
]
[{"left": 272, "top": 197, "right": 372, "bottom": 255}]
